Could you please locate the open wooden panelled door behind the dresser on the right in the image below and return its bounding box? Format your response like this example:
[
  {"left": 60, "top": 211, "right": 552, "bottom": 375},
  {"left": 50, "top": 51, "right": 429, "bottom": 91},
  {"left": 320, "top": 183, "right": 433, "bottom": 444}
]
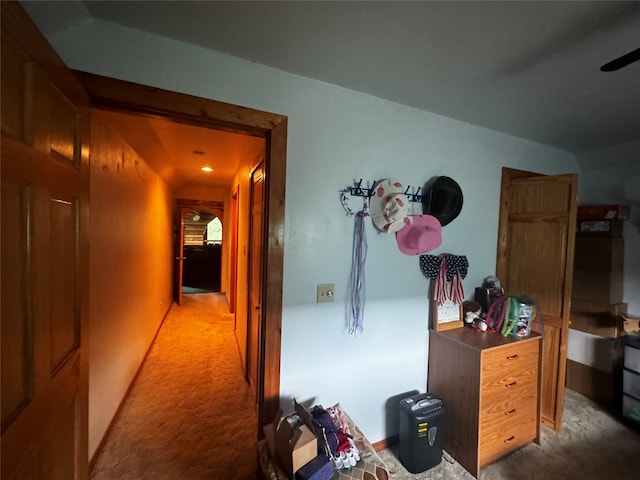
[{"left": 496, "top": 168, "right": 578, "bottom": 430}]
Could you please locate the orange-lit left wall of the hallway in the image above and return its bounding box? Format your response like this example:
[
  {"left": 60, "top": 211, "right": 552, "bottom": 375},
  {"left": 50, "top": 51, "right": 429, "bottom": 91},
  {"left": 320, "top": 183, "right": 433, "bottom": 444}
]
[{"left": 89, "top": 112, "right": 174, "bottom": 458}]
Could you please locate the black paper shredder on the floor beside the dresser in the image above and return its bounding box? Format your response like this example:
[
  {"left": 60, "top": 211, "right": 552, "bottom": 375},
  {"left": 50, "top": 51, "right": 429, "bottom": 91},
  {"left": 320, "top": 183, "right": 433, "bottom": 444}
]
[{"left": 399, "top": 393, "right": 446, "bottom": 473}]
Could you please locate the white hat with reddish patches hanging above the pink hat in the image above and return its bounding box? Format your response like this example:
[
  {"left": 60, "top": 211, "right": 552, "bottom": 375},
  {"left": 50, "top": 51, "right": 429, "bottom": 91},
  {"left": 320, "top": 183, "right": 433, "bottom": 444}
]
[{"left": 369, "top": 178, "right": 409, "bottom": 233}]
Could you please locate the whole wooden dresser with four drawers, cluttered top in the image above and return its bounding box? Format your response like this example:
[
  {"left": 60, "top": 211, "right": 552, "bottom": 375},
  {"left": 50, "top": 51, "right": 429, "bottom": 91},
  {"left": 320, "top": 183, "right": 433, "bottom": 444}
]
[{"left": 428, "top": 328, "right": 542, "bottom": 477}]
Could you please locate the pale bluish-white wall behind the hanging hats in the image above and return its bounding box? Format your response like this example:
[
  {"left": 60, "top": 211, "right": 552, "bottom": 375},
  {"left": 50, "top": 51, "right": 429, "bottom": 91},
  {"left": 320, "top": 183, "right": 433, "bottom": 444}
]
[{"left": 52, "top": 22, "right": 578, "bottom": 442}]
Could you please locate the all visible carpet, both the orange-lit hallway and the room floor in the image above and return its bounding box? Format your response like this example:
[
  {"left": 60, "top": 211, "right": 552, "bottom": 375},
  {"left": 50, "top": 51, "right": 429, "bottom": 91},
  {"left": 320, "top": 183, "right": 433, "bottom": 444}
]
[{"left": 91, "top": 293, "right": 640, "bottom": 480}]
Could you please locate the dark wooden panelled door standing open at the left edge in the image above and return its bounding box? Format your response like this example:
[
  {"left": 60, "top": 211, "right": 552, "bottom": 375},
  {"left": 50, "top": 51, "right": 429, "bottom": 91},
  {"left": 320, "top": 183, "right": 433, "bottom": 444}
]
[{"left": 1, "top": 2, "right": 89, "bottom": 480}]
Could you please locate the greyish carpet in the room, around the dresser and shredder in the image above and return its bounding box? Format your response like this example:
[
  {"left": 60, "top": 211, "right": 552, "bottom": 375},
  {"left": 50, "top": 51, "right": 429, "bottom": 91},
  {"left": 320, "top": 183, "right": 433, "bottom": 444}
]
[{"left": 380, "top": 390, "right": 640, "bottom": 480}]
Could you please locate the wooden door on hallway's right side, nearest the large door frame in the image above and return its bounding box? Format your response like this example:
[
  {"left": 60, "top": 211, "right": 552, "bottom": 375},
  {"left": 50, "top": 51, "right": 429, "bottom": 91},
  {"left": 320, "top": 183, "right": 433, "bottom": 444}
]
[{"left": 247, "top": 165, "right": 264, "bottom": 402}]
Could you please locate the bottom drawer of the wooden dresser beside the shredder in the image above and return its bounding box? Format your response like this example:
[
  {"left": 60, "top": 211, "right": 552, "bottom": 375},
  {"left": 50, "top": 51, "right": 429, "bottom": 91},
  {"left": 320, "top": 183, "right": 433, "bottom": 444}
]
[{"left": 478, "top": 412, "right": 537, "bottom": 466}]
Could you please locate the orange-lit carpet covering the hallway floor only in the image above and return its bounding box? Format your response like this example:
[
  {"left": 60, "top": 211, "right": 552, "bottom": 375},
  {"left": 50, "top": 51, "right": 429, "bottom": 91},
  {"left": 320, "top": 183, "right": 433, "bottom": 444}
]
[{"left": 90, "top": 293, "right": 257, "bottom": 480}]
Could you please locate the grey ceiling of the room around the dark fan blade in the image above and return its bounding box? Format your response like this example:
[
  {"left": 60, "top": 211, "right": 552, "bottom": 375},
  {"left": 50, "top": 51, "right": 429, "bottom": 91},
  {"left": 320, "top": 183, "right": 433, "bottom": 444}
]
[{"left": 21, "top": 1, "right": 640, "bottom": 178}]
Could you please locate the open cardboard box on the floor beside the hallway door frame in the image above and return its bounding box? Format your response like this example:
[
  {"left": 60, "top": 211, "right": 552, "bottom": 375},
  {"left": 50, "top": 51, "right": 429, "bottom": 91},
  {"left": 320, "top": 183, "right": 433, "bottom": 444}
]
[{"left": 263, "top": 401, "right": 318, "bottom": 479}]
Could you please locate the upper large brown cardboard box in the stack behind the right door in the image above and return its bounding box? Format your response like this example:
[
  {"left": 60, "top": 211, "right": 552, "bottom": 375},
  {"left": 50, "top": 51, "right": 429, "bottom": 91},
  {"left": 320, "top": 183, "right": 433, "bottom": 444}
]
[{"left": 573, "top": 237, "right": 624, "bottom": 272}]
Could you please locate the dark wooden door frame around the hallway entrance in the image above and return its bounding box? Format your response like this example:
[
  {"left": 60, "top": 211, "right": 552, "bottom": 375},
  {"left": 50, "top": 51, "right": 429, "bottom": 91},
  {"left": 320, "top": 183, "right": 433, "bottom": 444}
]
[{"left": 72, "top": 70, "right": 288, "bottom": 432}]
